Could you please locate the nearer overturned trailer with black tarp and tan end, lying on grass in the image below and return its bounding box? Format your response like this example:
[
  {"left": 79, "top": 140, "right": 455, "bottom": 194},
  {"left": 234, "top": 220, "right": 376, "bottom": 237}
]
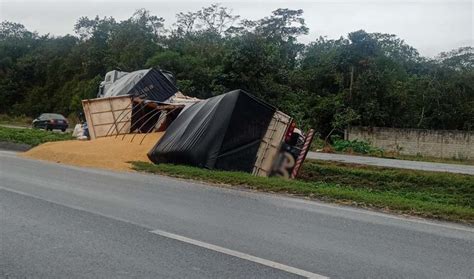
[{"left": 148, "top": 90, "right": 313, "bottom": 178}]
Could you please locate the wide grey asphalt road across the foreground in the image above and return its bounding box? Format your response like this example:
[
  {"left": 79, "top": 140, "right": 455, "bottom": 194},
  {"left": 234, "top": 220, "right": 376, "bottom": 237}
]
[{"left": 0, "top": 151, "right": 474, "bottom": 278}]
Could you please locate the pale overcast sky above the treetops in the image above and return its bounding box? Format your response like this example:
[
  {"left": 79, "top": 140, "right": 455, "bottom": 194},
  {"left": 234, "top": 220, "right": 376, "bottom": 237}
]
[{"left": 0, "top": 0, "right": 474, "bottom": 56}]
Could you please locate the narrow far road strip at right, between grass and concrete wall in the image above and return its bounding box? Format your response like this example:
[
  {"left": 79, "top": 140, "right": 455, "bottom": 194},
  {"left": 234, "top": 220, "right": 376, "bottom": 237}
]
[{"left": 306, "top": 152, "right": 474, "bottom": 175}]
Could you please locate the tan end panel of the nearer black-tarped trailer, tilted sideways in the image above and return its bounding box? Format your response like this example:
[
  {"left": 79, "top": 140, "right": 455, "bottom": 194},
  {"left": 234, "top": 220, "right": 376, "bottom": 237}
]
[{"left": 253, "top": 111, "right": 292, "bottom": 176}]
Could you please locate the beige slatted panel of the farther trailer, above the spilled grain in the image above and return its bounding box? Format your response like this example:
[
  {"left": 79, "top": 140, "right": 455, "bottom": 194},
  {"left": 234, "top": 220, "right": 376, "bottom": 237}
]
[{"left": 82, "top": 96, "right": 132, "bottom": 139}]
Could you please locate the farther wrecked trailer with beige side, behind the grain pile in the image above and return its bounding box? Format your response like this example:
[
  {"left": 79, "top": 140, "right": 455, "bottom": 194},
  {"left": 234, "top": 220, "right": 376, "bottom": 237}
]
[{"left": 82, "top": 68, "right": 199, "bottom": 139}]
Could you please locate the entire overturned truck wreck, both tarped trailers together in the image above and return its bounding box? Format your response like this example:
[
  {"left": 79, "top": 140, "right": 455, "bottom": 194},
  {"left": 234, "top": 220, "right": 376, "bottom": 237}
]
[{"left": 83, "top": 69, "right": 313, "bottom": 178}]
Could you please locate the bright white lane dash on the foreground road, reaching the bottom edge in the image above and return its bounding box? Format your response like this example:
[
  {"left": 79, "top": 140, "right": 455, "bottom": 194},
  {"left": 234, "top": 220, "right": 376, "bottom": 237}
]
[{"left": 151, "top": 230, "right": 329, "bottom": 279}]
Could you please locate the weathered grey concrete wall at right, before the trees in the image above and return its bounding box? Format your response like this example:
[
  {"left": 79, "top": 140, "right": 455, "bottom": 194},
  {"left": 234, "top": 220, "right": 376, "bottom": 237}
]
[{"left": 345, "top": 127, "right": 474, "bottom": 159}]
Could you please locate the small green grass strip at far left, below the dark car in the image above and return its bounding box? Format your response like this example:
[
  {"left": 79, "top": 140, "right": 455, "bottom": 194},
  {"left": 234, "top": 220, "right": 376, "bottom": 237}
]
[{"left": 0, "top": 126, "right": 73, "bottom": 146}]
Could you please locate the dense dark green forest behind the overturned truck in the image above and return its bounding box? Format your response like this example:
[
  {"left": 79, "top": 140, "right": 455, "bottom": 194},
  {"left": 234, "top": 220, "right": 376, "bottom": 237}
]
[{"left": 0, "top": 4, "right": 474, "bottom": 136}]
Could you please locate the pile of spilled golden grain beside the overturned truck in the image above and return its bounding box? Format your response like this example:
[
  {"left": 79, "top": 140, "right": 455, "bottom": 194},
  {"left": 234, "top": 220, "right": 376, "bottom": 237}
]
[{"left": 22, "top": 133, "right": 163, "bottom": 171}]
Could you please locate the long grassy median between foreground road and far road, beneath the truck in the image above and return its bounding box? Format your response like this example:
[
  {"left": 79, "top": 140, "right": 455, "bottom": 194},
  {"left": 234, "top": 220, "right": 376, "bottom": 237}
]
[{"left": 132, "top": 161, "right": 474, "bottom": 224}]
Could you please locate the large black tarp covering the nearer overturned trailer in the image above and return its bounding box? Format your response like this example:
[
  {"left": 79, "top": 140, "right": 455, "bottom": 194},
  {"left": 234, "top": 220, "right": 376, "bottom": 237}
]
[{"left": 148, "top": 90, "right": 276, "bottom": 172}]
